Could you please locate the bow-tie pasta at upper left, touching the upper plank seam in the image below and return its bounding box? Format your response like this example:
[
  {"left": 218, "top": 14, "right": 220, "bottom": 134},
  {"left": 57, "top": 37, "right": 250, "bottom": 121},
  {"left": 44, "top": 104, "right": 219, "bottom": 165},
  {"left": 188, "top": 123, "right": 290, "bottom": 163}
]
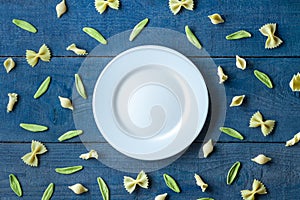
[{"left": 26, "top": 44, "right": 51, "bottom": 67}]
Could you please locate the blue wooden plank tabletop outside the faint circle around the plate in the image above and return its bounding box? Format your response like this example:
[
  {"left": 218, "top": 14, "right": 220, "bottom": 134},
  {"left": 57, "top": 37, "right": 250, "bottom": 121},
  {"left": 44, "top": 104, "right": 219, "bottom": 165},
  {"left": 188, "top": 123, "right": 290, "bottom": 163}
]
[{"left": 0, "top": 0, "right": 300, "bottom": 200}]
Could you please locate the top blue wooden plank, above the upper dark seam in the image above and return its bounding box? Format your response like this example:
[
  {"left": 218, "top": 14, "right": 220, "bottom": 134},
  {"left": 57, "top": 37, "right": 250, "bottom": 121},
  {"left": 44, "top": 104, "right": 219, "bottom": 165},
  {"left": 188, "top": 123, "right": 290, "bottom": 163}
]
[{"left": 0, "top": 0, "right": 300, "bottom": 56}]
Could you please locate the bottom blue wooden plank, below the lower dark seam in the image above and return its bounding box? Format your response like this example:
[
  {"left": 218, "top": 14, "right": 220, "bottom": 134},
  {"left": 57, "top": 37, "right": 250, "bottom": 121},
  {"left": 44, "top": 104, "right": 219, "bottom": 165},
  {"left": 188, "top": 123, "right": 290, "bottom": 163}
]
[{"left": 0, "top": 143, "right": 300, "bottom": 200}]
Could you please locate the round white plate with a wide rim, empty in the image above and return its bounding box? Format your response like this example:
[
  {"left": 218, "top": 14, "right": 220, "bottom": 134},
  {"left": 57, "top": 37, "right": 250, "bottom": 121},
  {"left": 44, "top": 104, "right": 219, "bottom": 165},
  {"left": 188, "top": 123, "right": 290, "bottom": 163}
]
[{"left": 92, "top": 45, "right": 209, "bottom": 160}]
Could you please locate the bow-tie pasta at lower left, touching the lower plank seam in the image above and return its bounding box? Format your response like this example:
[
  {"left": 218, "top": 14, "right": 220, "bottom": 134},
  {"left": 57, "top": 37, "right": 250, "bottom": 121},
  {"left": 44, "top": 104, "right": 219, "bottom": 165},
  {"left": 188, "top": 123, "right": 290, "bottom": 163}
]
[{"left": 22, "top": 140, "right": 47, "bottom": 167}]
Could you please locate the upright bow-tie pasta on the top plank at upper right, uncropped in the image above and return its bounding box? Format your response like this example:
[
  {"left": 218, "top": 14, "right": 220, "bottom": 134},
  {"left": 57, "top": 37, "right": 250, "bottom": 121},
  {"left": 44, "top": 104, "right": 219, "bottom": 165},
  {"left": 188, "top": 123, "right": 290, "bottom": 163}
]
[{"left": 259, "top": 23, "right": 282, "bottom": 49}]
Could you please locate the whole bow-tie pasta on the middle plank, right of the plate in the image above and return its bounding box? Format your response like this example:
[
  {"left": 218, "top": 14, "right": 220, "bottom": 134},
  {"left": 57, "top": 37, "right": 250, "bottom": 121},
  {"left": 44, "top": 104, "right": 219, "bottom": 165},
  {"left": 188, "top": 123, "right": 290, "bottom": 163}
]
[{"left": 249, "top": 111, "right": 275, "bottom": 136}]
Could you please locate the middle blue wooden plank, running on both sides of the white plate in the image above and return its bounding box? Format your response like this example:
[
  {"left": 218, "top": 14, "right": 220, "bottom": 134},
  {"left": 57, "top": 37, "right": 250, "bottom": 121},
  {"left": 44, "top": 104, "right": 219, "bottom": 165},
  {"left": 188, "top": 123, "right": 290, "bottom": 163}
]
[{"left": 0, "top": 58, "right": 300, "bottom": 142}]
